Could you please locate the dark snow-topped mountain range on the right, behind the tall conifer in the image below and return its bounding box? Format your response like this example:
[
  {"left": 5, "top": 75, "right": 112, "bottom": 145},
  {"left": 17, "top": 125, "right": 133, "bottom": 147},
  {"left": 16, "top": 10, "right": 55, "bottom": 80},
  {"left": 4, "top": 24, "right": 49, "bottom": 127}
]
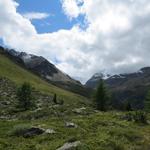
[{"left": 86, "top": 67, "right": 150, "bottom": 108}]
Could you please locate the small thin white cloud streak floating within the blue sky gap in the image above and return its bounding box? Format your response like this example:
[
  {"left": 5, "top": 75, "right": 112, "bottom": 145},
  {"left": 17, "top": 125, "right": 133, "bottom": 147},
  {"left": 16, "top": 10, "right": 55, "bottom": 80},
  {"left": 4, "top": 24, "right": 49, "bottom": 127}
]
[{"left": 23, "top": 12, "right": 50, "bottom": 20}]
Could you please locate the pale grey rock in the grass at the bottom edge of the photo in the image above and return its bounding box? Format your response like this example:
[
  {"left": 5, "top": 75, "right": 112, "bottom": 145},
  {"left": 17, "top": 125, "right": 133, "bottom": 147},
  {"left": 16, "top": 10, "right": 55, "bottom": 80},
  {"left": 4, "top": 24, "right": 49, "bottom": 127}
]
[{"left": 57, "top": 141, "right": 81, "bottom": 150}]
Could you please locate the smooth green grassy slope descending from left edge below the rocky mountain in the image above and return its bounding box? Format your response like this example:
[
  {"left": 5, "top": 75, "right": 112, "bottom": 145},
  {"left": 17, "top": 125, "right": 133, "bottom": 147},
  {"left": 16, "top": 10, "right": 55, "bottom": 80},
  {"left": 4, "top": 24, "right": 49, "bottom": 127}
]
[{"left": 0, "top": 54, "right": 88, "bottom": 104}]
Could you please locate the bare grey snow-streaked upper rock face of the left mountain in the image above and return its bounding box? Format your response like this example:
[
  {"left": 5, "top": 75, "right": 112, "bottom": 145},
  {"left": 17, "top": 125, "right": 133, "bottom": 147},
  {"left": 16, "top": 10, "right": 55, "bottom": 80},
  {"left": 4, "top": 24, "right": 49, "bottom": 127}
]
[{"left": 6, "top": 49, "right": 80, "bottom": 84}]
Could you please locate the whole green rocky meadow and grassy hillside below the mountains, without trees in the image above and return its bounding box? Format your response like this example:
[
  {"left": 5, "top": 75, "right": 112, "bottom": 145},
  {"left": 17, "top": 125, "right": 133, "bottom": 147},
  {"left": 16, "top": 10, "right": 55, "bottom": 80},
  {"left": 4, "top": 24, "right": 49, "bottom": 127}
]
[{"left": 0, "top": 46, "right": 150, "bottom": 150}]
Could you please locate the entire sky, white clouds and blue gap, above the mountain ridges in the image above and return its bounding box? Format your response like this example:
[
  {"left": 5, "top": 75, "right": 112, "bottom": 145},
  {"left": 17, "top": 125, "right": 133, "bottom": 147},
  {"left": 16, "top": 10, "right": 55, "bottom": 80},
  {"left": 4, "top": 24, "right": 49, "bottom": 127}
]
[{"left": 0, "top": 0, "right": 150, "bottom": 83}]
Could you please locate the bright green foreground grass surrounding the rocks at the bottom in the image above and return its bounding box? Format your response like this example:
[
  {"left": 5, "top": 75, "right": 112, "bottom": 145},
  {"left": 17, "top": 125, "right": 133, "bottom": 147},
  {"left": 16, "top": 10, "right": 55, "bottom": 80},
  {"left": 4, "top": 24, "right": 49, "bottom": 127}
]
[{"left": 0, "top": 112, "right": 150, "bottom": 150}]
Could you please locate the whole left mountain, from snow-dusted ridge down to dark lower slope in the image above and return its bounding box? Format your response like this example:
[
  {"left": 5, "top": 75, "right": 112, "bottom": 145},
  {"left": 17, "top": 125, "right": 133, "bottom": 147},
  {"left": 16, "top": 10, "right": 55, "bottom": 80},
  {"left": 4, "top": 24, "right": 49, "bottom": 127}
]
[{"left": 1, "top": 47, "right": 92, "bottom": 97}]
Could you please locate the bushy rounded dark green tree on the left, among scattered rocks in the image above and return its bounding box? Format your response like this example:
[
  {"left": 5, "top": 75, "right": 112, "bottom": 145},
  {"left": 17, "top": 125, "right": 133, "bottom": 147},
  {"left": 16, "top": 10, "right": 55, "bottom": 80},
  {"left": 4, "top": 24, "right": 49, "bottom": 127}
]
[{"left": 17, "top": 83, "right": 34, "bottom": 110}]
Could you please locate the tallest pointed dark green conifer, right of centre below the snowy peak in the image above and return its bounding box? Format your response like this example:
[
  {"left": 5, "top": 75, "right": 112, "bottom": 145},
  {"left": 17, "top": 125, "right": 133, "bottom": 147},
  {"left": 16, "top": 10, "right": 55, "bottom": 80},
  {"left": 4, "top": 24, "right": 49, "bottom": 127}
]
[{"left": 95, "top": 79, "right": 108, "bottom": 111}]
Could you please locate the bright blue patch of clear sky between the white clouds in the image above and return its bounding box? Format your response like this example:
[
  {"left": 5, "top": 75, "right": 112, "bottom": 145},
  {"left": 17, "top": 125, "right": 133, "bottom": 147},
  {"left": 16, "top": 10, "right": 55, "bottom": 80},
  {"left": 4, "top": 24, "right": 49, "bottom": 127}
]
[{"left": 16, "top": 0, "right": 83, "bottom": 33}]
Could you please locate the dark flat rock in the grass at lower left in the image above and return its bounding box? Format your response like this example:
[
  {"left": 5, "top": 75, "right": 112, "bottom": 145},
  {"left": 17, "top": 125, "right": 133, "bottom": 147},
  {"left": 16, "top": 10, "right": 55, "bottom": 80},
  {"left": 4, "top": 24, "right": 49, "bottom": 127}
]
[{"left": 23, "top": 127, "right": 45, "bottom": 138}]
